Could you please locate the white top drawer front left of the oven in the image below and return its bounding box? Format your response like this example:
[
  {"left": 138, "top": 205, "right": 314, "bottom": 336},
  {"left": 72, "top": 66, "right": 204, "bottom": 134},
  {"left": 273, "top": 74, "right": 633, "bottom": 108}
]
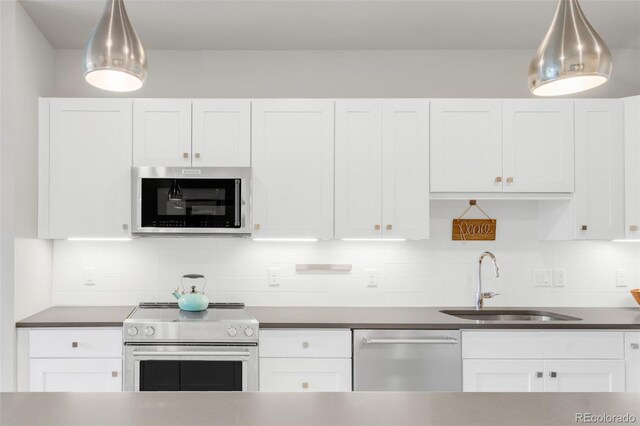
[{"left": 29, "top": 329, "right": 122, "bottom": 358}]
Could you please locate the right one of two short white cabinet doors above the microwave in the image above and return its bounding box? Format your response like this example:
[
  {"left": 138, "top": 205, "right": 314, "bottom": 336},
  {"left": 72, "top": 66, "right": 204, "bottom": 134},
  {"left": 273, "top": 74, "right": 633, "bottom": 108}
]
[{"left": 192, "top": 99, "right": 251, "bottom": 167}]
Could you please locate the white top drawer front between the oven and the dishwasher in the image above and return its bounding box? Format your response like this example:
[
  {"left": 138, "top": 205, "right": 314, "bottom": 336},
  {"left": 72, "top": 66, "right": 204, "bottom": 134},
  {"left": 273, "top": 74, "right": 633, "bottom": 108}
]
[{"left": 258, "top": 329, "right": 351, "bottom": 358}]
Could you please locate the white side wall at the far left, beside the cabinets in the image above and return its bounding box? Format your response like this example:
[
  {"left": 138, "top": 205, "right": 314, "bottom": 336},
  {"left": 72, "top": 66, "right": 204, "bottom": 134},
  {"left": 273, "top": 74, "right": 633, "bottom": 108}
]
[{"left": 0, "top": 0, "right": 55, "bottom": 391}]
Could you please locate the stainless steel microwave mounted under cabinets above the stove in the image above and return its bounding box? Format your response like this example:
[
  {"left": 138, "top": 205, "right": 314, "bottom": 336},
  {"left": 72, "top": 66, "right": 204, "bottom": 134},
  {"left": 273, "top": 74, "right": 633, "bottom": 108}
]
[{"left": 131, "top": 167, "right": 251, "bottom": 237}]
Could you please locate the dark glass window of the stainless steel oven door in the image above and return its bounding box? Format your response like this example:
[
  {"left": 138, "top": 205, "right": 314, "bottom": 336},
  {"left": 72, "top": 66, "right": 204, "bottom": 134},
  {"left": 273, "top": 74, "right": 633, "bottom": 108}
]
[{"left": 140, "top": 361, "right": 242, "bottom": 391}]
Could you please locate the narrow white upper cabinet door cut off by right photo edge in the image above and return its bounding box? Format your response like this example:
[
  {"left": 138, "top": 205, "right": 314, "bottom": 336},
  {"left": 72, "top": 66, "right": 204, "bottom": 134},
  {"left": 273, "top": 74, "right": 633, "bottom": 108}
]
[{"left": 624, "top": 96, "right": 640, "bottom": 240}]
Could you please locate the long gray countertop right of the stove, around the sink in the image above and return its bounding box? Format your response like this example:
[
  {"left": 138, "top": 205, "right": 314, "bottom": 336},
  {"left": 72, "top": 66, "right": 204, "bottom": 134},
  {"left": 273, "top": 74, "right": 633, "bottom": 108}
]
[{"left": 248, "top": 307, "right": 640, "bottom": 329}]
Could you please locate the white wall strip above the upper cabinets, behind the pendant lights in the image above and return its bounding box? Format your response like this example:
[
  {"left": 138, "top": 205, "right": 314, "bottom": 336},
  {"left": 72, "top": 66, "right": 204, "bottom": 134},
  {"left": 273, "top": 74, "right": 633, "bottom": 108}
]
[{"left": 55, "top": 49, "right": 640, "bottom": 98}]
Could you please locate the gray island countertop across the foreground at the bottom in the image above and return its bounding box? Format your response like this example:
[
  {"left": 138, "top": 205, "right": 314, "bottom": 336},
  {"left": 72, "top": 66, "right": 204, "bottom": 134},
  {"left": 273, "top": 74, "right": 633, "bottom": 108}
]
[{"left": 0, "top": 392, "right": 640, "bottom": 426}]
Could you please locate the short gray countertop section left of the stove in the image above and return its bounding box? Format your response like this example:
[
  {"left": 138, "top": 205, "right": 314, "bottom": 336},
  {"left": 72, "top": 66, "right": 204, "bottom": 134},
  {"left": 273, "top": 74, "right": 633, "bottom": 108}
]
[{"left": 16, "top": 306, "right": 135, "bottom": 327}]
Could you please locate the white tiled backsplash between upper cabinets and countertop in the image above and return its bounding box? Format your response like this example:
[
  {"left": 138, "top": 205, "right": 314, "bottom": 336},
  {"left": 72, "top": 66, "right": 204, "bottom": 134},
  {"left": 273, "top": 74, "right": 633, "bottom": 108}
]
[{"left": 53, "top": 201, "right": 640, "bottom": 306}]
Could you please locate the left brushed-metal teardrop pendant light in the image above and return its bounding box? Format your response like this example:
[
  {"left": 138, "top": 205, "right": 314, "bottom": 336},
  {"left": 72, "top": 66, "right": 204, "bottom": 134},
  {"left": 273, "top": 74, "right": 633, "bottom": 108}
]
[{"left": 82, "top": 0, "right": 147, "bottom": 92}]
